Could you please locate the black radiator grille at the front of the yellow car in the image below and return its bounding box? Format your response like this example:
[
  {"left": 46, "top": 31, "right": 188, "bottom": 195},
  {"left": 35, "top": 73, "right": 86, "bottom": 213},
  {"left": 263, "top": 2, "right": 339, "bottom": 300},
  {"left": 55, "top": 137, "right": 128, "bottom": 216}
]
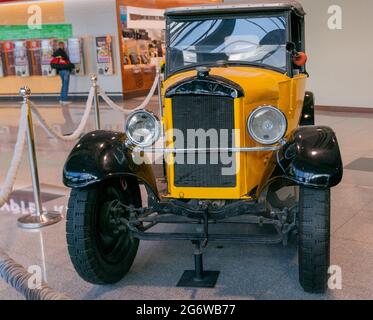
[{"left": 172, "top": 95, "right": 236, "bottom": 188}]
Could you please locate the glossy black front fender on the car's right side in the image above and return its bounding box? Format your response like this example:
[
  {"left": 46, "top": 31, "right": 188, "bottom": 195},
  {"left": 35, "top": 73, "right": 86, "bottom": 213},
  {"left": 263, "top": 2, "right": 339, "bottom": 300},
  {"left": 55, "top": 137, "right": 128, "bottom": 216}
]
[{"left": 258, "top": 126, "right": 343, "bottom": 193}]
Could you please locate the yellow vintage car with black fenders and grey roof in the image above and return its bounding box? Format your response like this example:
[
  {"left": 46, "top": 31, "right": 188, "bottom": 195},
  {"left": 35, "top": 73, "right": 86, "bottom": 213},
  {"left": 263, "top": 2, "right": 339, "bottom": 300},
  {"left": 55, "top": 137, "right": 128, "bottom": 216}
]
[{"left": 64, "top": 1, "right": 343, "bottom": 293}]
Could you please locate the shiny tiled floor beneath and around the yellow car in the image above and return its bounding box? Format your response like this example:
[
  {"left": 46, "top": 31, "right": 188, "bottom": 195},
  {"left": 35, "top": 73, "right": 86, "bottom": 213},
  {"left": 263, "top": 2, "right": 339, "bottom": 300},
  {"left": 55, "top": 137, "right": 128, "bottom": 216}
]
[{"left": 0, "top": 99, "right": 373, "bottom": 299}]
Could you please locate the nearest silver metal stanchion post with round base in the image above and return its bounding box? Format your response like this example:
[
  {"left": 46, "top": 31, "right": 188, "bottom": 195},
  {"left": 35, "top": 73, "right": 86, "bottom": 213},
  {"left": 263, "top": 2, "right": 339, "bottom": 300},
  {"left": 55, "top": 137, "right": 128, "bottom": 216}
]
[{"left": 18, "top": 87, "right": 62, "bottom": 229}]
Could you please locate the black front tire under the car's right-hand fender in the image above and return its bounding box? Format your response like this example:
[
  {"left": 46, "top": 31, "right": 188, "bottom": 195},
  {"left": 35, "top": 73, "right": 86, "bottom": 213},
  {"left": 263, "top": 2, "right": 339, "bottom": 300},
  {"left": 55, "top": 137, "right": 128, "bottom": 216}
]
[{"left": 298, "top": 187, "right": 330, "bottom": 294}]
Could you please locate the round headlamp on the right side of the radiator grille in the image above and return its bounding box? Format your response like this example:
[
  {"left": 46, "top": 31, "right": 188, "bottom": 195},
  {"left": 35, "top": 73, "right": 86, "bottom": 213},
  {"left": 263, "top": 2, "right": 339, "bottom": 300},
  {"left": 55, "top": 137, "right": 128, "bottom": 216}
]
[{"left": 247, "top": 106, "right": 287, "bottom": 145}]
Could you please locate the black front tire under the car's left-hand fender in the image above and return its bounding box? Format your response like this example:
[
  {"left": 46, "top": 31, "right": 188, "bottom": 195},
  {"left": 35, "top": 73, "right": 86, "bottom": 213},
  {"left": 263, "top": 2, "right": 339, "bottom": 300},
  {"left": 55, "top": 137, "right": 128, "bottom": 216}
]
[{"left": 66, "top": 179, "right": 141, "bottom": 284}]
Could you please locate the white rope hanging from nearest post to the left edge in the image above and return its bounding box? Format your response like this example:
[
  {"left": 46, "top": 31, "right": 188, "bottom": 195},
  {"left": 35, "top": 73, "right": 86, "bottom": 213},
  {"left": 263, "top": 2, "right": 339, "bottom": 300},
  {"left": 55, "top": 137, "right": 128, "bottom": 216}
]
[{"left": 0, "top": 104, "right": 28, "bottom": 208}]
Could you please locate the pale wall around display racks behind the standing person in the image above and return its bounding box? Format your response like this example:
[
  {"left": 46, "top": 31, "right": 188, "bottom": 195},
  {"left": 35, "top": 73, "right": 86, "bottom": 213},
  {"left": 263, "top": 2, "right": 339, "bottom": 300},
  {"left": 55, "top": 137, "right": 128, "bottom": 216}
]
[{"left": 0, "top": 0, "right": 122, "bottom": 94}]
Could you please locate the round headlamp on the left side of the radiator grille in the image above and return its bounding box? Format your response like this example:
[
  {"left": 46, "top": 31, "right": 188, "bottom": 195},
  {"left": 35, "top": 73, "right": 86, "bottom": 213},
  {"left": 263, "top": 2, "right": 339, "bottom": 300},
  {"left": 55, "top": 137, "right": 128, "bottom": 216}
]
[{"left": 125, "top": 110, "right": 161, "bottom": 147}]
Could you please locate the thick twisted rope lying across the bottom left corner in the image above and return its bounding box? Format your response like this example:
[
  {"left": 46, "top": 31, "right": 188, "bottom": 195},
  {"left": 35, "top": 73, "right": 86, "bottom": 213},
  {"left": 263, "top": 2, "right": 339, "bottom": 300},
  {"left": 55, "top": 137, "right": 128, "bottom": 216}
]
[{"left": 0, "top": 249, "right": 71, "bottom": 300}]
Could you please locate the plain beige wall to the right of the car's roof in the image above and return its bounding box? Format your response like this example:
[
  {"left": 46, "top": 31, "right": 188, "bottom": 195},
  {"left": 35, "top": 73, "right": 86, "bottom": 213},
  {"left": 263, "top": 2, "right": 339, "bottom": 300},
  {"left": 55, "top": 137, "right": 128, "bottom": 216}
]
[{"left": 224, "top": 0, "right": 373, "bottom": 108}]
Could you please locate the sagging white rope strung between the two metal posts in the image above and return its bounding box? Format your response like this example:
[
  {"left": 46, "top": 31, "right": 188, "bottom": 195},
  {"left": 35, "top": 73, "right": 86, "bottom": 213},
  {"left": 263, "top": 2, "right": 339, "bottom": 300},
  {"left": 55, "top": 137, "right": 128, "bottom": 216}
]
[{"left": 30, "top": 88, "right": 95, "bottom": 141}]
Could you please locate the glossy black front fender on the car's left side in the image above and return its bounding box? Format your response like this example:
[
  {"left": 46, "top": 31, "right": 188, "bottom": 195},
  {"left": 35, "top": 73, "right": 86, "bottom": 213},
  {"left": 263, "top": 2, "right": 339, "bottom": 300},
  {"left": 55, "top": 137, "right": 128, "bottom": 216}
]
[{"left": 63, "top": 131, "right": 158, "bottom": 195}]
